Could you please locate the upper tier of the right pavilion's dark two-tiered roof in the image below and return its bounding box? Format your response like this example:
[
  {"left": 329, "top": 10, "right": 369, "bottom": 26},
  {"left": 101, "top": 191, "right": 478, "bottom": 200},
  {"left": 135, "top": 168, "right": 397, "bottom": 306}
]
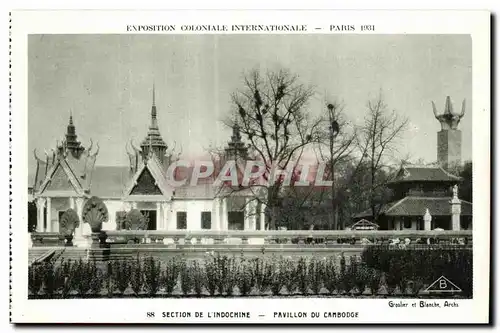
[{"left": 391, "top": 166, "right": 462, "bottom": 184}]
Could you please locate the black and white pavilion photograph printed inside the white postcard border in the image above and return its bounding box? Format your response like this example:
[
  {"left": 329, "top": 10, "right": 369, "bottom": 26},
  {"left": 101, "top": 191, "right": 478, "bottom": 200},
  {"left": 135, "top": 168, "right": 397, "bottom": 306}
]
[{"left": 8, "top": 9, "right": 489, "bottom": 322}]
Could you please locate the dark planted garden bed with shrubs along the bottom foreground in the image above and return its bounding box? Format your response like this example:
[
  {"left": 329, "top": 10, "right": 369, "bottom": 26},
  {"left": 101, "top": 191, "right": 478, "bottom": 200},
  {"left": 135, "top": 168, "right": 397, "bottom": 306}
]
[{"left": 28, "top": 247, "right": 472, "bottom": 299}]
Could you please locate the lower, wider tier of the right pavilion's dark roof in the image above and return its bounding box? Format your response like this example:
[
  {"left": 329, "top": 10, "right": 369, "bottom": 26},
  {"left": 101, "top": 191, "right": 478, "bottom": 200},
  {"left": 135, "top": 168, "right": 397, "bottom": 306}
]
[{"left": 354, "top": 196, "right": 472, "bottom": 218}]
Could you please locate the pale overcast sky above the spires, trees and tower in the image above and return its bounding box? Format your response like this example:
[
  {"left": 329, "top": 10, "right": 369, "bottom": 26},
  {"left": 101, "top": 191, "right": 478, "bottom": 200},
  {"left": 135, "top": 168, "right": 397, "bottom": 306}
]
[{"left": 28, "top": 34, "right": 472, "bottom": 170}]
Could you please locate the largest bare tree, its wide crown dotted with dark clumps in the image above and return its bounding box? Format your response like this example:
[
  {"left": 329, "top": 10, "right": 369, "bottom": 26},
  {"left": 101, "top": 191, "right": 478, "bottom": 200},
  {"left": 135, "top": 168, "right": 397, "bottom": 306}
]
[{"left": 225, "top": 70, "right": 321, "bottom": 229}]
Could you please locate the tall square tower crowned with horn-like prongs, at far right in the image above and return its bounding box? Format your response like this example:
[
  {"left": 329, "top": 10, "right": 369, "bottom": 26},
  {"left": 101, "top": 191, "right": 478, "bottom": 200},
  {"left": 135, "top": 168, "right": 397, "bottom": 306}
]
[{"left": 432, "top": 96, "right": 465, "bottom": 169}]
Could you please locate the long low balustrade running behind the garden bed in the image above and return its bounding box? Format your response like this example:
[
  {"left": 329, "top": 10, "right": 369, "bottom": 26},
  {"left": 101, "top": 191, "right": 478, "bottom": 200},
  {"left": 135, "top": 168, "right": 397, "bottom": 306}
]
[{"left": 31, "top": 230, "right": 472, "bottom": 247}]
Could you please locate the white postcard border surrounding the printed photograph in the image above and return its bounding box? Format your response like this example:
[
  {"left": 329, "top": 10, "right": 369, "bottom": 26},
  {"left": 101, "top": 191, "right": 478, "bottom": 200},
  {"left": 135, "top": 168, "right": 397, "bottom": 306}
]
[{"left": 11, "top": 10, "right": 491, "bottom": 323}]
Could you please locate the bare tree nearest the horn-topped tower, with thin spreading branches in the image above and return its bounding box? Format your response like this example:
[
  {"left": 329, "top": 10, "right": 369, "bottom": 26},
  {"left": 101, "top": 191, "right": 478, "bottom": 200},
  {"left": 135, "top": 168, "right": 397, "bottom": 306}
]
[{"left": 359, "top": 93, "right": 408, "bottom": 221}]
